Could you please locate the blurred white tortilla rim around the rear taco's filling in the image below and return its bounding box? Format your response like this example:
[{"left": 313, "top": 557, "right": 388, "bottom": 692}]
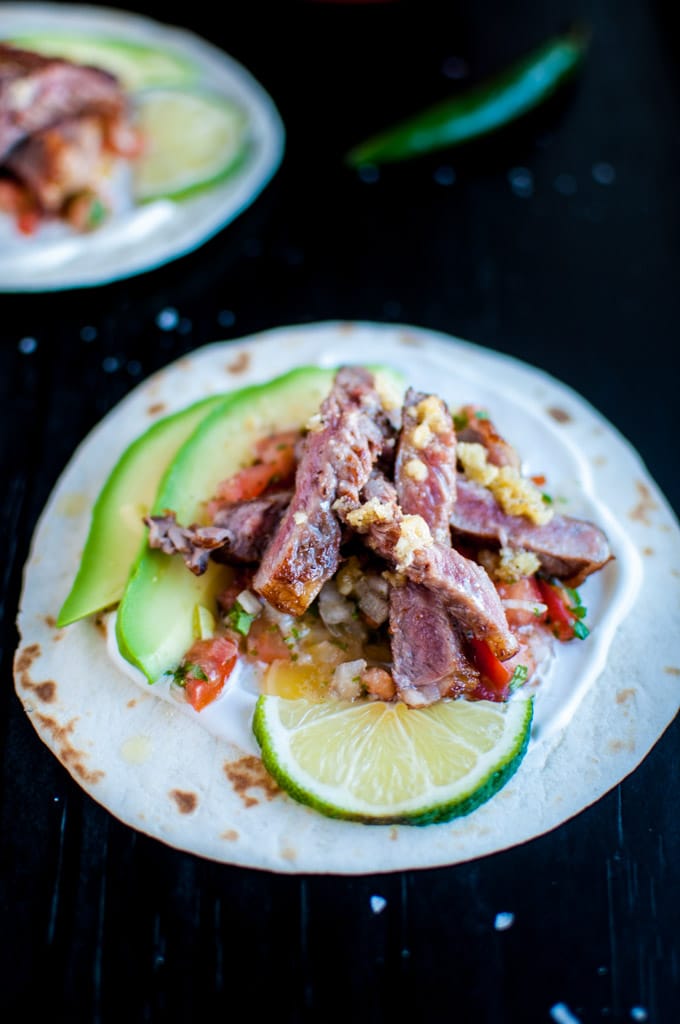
[{"left": 0, "top": 3, "right": 285, "bottom": 292}]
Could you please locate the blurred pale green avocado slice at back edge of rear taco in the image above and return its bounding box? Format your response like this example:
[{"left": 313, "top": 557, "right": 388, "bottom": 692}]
[{"left": 11, "top": 32, "right": 198, "bottom": 92}]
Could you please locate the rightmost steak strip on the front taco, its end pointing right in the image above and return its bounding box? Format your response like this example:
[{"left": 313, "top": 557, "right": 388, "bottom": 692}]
[{"left": 451, "top": 475, "right": 612, "bottom": 587}]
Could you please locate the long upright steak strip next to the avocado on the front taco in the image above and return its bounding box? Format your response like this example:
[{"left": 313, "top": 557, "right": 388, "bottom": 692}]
[{"left": 253, "top": 367, "right": 387, "bottom": 615}]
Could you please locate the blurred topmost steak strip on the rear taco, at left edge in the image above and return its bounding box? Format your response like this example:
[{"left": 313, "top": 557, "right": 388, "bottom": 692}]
[{"left": 0, "top": 44, "right": 125, "bottom": 163}]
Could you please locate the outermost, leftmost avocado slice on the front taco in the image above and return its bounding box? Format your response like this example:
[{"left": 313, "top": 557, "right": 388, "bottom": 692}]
[{"left": 56, "top": 394, "right": 225, "bottom": 627}]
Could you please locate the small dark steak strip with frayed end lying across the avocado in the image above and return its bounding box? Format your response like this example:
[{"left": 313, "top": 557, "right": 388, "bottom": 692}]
[{"left": 144, "top": 490, "right": 291, "bottom": 575}]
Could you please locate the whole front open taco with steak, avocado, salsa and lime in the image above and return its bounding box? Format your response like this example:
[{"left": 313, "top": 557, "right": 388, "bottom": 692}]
[{"left": 15, "top": 324, "right": 678, "bottom": 873}]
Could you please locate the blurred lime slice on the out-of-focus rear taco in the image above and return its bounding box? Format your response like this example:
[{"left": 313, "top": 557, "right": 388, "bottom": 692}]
[{"left": 134, "top": 89, "right": 249, "bottom": 202}]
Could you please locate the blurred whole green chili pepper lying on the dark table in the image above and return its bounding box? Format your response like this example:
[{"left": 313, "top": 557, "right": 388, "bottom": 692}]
[{"left": 345, "top": 26, "right": 590, "bottom": 167}]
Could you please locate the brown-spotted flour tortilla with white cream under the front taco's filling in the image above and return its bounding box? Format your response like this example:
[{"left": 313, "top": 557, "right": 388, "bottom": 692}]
[{"left": 15, "top": 323, "right": 680, "bottom": 874}]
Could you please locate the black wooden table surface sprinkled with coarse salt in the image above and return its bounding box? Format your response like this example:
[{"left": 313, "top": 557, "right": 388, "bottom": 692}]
[{"left": 0, "top": 0, "right": 680, "bottom": 1024}]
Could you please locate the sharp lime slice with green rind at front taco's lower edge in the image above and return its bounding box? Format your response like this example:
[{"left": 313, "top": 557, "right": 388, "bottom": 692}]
[{"left": 253, "top": 694, "right": 534, "bottom": 825}]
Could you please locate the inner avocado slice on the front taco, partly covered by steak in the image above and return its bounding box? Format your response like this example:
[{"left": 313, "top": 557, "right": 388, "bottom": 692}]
[{"left": 116, "top": 367, "right": 342, "bottom": 682}]
